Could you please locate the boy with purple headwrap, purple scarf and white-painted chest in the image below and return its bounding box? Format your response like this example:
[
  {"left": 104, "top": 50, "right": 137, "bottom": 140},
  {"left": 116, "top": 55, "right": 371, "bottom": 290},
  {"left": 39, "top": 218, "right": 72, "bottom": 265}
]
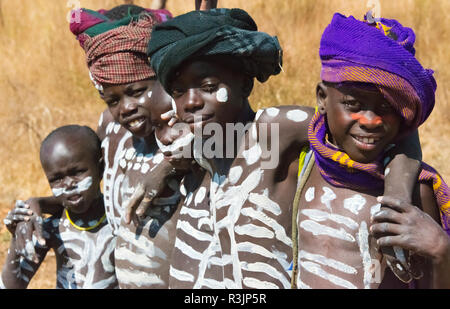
[{"left": 293, "top": 14, "right": 450, "bottom": 288}]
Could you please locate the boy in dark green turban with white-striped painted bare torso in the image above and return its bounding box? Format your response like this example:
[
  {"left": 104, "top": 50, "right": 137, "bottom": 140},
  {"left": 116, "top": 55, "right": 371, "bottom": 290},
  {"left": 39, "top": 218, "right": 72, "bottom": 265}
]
[{"left": 149, "top": 9, "right": 428, "bottom": 288}]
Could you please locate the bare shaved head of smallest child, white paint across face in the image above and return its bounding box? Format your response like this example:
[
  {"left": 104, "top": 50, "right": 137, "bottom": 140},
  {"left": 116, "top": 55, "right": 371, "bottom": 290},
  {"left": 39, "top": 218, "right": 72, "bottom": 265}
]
[{"left": 40, "top": 125, "right": 103, "bottom": 214}]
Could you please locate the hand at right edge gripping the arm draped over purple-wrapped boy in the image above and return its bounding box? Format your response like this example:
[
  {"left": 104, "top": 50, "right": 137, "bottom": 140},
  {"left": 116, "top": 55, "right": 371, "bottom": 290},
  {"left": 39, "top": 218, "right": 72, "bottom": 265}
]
[{"left": 370, "top": 196, "right": 450, "bottom": 263}]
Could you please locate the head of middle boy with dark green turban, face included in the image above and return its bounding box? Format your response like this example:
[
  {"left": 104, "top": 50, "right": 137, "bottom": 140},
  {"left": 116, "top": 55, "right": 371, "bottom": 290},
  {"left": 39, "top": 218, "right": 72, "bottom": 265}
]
[{"left": 148, "top": 9, "right": 281, "bottom": 135}]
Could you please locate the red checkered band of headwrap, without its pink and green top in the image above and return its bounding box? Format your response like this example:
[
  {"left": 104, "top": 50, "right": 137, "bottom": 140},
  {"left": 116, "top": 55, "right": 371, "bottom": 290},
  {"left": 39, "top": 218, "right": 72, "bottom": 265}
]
[{"left": 79, "top": 15, "right": 158, "bottom": 91}]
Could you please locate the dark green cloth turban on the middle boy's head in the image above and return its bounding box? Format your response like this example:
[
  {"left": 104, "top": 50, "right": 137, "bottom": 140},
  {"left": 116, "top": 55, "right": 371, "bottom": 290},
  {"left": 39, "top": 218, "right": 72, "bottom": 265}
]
[{"left": 148, "top": 9, "right": 282, "bottom": 93}]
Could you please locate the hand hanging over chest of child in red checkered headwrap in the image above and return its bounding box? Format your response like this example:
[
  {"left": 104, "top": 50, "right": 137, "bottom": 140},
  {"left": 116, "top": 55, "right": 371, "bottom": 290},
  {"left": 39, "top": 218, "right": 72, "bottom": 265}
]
[{"left": 124, "top": 160, "right": 175, "bottom": 225}]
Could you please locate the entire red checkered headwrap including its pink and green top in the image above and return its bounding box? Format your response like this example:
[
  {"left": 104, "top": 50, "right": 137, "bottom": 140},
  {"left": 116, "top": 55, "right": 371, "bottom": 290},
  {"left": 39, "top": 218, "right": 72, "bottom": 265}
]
[{"left": 70, "top": 9, "right": 171, "bottom": 91}]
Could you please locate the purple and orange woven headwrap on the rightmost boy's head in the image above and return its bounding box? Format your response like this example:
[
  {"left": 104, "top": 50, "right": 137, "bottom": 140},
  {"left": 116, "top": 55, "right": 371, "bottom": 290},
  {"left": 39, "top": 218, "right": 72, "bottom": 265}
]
[{"left": 320, "top": 13, "right": 436, "bottom": 132}]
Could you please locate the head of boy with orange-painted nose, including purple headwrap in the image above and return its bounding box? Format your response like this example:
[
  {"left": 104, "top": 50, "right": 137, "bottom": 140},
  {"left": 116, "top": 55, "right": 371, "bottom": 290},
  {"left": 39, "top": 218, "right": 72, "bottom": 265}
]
[{"left": 317, "top": 14, "right": 436, "bottom": 163}]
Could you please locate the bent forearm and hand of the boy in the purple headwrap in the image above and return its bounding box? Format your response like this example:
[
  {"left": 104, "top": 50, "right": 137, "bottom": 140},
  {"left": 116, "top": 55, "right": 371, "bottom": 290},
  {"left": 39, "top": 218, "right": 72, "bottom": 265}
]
[{"left": 371, "top": 191, "right": 450, "bottom": 289}]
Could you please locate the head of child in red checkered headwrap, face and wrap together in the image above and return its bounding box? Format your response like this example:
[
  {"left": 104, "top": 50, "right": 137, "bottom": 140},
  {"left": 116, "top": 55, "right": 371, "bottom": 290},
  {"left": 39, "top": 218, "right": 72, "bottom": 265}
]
[{"left": 70, "top": 5, "right": 171, "bottom": 138}]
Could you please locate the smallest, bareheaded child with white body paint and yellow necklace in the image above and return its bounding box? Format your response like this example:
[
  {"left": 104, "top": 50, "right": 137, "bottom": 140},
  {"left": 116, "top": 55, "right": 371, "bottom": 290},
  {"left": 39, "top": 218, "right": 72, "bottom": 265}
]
[{"left": 1, "top": 125, "right": 118, "bottom": 289}]
